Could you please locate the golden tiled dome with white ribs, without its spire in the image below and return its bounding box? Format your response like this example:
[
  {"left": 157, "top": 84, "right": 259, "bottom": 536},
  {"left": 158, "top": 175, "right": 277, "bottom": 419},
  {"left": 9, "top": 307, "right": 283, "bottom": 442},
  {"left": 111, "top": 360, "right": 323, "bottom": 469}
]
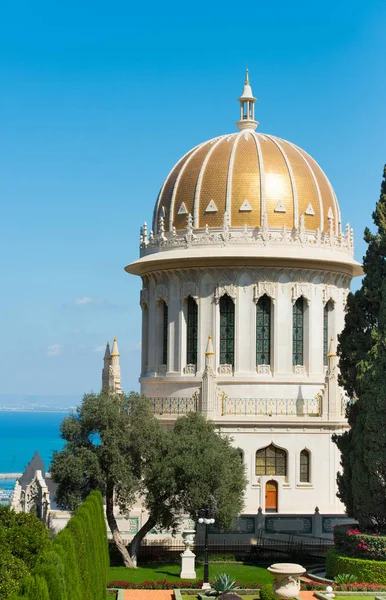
[{"left": 153, "top": 129, "right": 341, "bottom": 234}]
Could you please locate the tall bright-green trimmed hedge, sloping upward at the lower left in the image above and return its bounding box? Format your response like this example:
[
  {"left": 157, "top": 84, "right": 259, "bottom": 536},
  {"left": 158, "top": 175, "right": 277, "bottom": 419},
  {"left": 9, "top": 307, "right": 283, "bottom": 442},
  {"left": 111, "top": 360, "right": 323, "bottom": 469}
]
[{"left": 14, "top": 492, "right": 109, "bottom": 600}]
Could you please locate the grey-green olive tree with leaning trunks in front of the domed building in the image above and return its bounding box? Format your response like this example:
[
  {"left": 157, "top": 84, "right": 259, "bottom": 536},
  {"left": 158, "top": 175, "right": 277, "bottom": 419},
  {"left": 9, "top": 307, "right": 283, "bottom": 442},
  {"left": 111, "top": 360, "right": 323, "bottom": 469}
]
[{"left": 51, "top": 392, "right": 246, "bottom": 567}]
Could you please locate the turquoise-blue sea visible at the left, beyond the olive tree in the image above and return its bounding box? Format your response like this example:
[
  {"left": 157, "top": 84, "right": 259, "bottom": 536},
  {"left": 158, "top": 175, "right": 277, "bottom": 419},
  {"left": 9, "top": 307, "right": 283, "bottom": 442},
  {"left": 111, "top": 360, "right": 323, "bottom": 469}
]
[{"left": 0, "top": 410, "right": 69, "bottom": 490}]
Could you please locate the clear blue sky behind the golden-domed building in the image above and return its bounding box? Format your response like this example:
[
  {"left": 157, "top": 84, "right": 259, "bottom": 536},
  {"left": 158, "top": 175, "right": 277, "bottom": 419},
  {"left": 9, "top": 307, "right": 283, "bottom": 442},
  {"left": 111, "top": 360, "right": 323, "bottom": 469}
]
[{"left": 0, "top": 0, "right": 386, "bottom": 404}]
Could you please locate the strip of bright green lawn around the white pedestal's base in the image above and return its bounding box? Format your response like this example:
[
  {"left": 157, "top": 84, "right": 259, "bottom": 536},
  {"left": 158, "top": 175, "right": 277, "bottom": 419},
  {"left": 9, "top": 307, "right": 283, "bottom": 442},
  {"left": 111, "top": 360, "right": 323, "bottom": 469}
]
[{"left": 108, "top": 563, "right": 273, "bottom": 585}]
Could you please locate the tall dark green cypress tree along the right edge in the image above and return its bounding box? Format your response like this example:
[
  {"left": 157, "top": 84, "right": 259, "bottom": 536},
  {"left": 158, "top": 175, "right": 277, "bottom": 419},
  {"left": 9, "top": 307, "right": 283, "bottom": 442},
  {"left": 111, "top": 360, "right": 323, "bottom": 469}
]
[{"left": 333, "top": 166, "right": 386, "bottom": 531}]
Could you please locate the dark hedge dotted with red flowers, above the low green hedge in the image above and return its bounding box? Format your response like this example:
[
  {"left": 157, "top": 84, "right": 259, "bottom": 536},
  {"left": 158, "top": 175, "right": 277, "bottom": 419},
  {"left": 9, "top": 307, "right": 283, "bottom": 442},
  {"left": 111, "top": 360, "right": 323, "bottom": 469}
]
[{"left": 334, "top": 524, "right": 386, "bottom": 561}]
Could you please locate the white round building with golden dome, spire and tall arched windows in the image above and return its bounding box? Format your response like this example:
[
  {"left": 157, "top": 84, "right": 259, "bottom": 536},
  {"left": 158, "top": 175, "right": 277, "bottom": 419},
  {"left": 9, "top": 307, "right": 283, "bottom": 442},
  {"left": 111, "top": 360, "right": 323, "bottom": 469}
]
[{"left": 123, "top": 72, "right": 362, "bottom": 516}]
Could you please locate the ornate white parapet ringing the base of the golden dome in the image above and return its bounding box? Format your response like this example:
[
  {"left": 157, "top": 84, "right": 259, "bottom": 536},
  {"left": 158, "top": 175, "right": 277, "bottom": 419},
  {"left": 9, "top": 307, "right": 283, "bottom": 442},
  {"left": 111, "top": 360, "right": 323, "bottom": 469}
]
[{"left": 140, "top": 213, "right": 354, "bottom": 256}]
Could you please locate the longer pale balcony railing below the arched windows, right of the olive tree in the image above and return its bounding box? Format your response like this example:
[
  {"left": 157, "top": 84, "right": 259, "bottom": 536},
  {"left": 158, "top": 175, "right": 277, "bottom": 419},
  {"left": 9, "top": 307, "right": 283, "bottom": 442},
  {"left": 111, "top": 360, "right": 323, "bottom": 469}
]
[{"left": 221, "top": 397, "right": 322, "bottom": 417}]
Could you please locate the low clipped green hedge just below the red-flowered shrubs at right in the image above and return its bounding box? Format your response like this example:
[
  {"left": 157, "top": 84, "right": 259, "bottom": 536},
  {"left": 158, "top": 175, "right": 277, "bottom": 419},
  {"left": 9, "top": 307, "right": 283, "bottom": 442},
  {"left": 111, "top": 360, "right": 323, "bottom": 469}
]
[{"left": 326, "top": 549, "right": 386, "bottom": 584}]
